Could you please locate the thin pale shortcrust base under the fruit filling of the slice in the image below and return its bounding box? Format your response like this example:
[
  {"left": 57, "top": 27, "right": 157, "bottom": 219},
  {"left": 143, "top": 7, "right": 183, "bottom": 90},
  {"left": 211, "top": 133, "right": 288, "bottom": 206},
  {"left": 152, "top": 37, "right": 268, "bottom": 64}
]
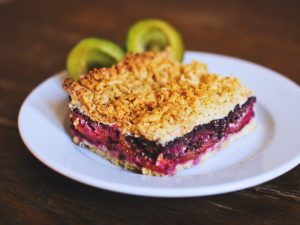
[{"left": 73, "top": 118, "right": 256, "bottom": 176}]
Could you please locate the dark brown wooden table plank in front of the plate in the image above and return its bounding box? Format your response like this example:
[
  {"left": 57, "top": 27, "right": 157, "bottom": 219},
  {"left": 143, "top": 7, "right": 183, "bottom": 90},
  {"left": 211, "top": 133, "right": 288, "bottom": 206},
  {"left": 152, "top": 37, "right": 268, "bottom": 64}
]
[{"left": 0, "top": 128, "right": 300, "bottom": 224}]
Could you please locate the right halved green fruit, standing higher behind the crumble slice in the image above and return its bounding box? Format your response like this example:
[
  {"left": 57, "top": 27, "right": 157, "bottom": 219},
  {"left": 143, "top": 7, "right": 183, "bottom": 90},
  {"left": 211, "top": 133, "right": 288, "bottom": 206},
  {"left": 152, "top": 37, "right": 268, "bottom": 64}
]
[{"left": 126, "top": 19, "right": 184, "bottom": 61}]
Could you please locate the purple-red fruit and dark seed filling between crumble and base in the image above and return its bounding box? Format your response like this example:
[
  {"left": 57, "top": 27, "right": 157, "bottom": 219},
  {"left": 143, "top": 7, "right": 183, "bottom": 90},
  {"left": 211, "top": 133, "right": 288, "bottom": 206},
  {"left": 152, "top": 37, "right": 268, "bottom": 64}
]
[{"left": 70, "top": 97, "right": 256, "bottom": 175}]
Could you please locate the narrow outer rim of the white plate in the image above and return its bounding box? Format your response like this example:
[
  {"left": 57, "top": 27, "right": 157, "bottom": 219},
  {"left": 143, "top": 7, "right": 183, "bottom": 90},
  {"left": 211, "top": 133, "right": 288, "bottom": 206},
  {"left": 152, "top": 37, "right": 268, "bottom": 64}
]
[{"left": 18, "top": 51, "right": 300, "bottom": 197}]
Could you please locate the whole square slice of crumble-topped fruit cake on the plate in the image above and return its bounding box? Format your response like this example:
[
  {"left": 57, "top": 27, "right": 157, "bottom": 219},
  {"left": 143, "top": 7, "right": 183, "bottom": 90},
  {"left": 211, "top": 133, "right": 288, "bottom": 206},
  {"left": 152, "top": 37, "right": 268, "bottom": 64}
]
[{"left": 63, "top": 51, "right": 256, "bottom": 175}]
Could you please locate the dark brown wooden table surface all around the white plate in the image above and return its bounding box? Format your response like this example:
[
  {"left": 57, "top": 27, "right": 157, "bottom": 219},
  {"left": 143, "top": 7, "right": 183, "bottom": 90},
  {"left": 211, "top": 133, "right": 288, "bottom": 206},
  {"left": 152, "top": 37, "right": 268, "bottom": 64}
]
[{"left": 0, "top": 0, "right": 300, "bottom": 225}]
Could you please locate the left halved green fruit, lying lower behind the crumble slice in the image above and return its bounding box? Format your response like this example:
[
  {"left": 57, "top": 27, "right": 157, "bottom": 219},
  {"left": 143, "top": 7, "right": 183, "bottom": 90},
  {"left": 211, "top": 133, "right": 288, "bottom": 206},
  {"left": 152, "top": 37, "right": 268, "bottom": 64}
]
[{"left": 67, "top": 38, "right": 124, "bottom": 81}]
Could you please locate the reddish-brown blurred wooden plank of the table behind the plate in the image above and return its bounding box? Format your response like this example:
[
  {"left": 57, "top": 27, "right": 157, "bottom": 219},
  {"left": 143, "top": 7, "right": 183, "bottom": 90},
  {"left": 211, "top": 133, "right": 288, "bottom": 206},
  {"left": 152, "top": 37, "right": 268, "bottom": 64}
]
[{"left": 0, "top": 0, "right": 300, "bottom": 123}]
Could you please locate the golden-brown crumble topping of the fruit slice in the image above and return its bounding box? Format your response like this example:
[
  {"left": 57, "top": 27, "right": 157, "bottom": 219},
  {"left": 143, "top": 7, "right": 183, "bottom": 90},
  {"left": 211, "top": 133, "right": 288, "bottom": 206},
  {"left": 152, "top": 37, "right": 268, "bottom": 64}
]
[{"left": 63, "top": 51, "right": 252, "bottom": 144}]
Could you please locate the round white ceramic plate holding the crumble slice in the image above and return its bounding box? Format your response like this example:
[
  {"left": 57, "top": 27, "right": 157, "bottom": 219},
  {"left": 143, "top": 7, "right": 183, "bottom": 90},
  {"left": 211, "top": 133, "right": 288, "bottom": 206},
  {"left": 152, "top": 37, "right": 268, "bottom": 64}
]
[{"left": 19, "top": 52, "right": 300, "bottom": 197}]
